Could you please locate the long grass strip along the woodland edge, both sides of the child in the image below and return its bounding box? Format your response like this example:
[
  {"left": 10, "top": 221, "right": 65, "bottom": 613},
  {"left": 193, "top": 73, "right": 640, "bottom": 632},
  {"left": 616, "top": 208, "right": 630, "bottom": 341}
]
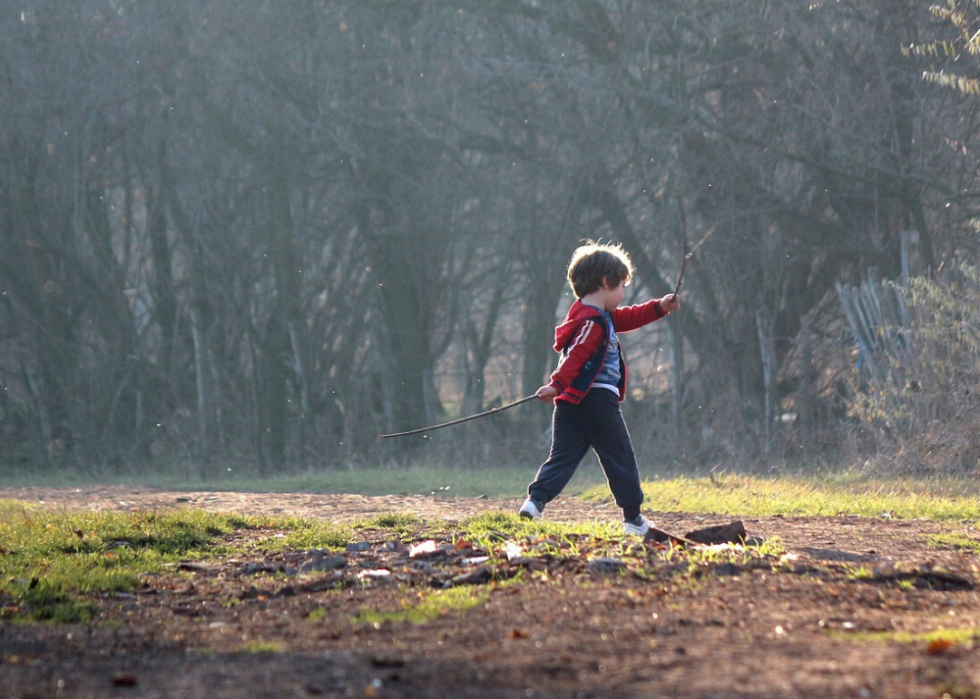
[{"left": 9, "top": 463, "right": 980, "bottom": 521}]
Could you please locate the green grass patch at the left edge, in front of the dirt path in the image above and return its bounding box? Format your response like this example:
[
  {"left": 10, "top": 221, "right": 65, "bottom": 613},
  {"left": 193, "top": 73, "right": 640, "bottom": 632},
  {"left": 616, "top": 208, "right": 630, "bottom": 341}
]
[{"left": 0, "top": 502, "right": 349, "bottom": 622}]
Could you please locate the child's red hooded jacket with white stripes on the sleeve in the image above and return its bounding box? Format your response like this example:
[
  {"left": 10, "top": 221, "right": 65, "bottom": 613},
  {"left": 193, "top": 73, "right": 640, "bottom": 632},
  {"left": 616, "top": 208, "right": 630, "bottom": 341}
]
[{"left": 550, "top": 299, "right": 667, "bottom": 403}]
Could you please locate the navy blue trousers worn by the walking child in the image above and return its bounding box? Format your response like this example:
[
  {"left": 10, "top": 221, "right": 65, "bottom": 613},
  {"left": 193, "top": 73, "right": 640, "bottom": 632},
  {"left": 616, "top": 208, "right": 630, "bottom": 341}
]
[{"left": 527, "top": 388, "right": 643, "bottom": 518}]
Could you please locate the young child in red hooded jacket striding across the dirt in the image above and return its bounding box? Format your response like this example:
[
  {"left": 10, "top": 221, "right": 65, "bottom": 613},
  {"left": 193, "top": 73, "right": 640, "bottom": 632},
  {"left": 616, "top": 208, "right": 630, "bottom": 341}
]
[{"left": 520, "top": 241, "right": 680, "bottom": 536}]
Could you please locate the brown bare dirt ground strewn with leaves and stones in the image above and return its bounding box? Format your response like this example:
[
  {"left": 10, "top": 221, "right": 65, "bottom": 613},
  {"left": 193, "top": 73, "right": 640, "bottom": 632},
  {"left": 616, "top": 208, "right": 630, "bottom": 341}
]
[{"left": 0, "top": 487, "right": 980, "bottom": 699}]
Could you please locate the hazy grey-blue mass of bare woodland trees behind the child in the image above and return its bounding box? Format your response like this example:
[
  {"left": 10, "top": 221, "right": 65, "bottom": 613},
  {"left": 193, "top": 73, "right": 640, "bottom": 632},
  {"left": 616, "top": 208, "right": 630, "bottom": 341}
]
[{"left": 0, "top": 0, "right": 978, "bottom": 477}]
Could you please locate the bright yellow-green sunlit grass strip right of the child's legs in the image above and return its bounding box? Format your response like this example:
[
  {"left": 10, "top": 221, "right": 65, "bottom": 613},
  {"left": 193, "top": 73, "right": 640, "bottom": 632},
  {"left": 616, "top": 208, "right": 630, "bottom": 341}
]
[{"left": 583, "top": 474, "right": 980, "bottom": 521}]
